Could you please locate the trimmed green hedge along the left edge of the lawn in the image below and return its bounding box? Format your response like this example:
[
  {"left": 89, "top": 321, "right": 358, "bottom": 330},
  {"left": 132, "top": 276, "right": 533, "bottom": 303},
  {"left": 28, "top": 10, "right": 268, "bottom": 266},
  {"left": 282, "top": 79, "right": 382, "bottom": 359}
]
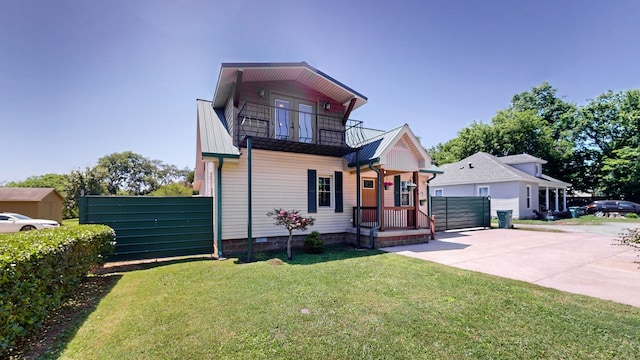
[{"left": 0, "top": 225, "right": 115, "bottom": 356}]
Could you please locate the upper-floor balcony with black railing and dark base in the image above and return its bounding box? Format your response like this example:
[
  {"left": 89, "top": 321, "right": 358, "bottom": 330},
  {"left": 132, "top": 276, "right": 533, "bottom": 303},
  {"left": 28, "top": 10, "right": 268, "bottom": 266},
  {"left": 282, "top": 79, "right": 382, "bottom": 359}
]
[{"left": 234, "top": 102, "right": 365, "bottom": 157}]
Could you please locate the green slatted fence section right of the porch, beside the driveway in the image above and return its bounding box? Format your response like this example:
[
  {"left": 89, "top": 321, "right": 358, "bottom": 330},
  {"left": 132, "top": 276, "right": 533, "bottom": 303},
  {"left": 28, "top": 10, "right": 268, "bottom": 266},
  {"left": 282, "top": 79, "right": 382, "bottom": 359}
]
[{"left": 431, "top": 196, "right": 491, "bottom": 231}]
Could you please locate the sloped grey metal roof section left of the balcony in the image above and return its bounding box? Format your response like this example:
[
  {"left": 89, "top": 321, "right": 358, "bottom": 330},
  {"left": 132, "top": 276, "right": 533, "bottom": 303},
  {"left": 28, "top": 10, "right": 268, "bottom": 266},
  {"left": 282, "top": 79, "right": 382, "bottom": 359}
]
[{"left": 196, "top": 100, "right": 240, "bottom": 157}]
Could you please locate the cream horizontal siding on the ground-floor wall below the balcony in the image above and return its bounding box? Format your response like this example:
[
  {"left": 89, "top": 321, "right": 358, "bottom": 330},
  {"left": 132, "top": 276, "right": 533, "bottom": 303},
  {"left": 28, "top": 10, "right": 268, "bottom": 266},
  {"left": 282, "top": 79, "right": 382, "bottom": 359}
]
[{"left": 222, "top": 149, "right": 356, "bottom": 239}]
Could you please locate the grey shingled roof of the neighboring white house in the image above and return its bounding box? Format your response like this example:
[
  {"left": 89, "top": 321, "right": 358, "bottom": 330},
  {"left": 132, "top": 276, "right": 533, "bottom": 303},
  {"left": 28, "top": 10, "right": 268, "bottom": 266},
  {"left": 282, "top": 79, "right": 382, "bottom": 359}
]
[{"left": 430, "top": 152, "right": 570, "bottom": 187}]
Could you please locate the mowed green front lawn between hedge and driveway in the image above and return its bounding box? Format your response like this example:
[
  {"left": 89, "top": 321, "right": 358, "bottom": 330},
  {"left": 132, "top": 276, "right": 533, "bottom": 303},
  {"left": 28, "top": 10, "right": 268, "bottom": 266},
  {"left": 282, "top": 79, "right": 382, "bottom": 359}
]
[{"left": 27, "top": 247, "right": 640, "bottom": 359}]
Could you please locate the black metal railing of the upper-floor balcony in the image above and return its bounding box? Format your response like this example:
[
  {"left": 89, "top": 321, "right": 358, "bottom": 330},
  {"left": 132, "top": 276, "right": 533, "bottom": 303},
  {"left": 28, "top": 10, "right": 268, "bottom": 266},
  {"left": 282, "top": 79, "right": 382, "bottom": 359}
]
[{"left": 236, "top": 102, "right": 366, "bottom": 147}]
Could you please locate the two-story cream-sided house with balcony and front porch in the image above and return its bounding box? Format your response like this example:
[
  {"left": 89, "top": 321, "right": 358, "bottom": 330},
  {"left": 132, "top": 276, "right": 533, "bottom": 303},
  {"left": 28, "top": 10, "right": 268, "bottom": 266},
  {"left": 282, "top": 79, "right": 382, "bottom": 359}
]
[{"left": 194, "top": 62, "right": 439, "bottom": 256}]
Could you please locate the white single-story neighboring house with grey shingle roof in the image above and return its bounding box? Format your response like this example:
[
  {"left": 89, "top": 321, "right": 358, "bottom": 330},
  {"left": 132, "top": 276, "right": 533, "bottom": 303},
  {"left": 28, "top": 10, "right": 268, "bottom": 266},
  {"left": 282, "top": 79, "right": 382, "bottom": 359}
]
[{"left": 429, "top": 152, "right": 571, "bottom": 219}]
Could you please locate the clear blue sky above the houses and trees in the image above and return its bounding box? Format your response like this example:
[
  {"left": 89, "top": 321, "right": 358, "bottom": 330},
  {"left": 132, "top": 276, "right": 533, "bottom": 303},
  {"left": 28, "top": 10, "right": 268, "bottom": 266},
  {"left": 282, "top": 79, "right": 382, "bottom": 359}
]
[{"left": 0, "top": 0, "right": 640, "bottom": 184}]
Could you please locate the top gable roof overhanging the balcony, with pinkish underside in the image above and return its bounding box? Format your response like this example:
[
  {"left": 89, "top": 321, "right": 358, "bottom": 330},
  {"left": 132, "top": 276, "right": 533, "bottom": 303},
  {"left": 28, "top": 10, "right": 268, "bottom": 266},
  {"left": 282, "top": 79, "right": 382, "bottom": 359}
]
[{"left": 213, "top": 61, "right": 367, "bottom": 110}]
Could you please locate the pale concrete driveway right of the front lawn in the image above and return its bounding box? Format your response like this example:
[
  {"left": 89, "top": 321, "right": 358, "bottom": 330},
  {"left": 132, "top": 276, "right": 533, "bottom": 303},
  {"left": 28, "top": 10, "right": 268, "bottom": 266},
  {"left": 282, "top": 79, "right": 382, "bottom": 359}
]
[{"left": 382, "top": 224, "right": 640, "bottom": 307}]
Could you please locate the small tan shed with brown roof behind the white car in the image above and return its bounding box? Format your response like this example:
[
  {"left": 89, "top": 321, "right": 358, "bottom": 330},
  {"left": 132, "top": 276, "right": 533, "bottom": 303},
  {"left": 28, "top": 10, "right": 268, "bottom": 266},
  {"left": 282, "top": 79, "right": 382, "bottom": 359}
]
[{"left": 0, "top": 187, "right": 64, "bottom": 223}]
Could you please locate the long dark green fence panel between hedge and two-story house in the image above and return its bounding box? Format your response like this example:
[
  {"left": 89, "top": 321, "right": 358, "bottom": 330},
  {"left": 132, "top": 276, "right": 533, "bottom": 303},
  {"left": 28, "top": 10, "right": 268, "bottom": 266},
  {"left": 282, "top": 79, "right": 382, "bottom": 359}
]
[{"left": 79, "top": 196, "right": 213, "bottom": 260}]
